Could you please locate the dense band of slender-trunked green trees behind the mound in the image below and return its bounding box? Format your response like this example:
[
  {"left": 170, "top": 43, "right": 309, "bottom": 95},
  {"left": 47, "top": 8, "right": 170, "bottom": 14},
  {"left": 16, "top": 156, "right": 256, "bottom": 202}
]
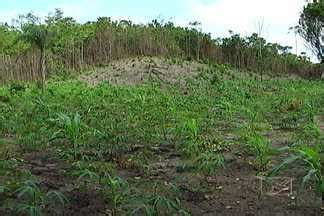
[{"left": 0, "top": 10, "right": 320, "bottom": 82}]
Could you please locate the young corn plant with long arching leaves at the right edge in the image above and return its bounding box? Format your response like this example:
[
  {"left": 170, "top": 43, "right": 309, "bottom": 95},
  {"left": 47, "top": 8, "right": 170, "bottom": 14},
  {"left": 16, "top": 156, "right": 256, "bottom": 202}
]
[{"left": 269, "top": 145, "right": 324, "bottom": 208}]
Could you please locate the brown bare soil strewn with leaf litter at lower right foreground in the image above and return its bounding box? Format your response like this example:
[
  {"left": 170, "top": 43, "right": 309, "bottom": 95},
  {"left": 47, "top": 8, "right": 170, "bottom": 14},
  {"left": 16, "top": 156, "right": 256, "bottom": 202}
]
[{"left": 114, "top": 139, "right": 322, "bottom": 216}]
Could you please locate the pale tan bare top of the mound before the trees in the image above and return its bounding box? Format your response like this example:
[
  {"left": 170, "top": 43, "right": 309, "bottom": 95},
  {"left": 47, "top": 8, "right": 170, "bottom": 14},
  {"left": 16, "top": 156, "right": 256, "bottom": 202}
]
[{"left": 80, "top": 57, "right": 206, "bottom": 85}]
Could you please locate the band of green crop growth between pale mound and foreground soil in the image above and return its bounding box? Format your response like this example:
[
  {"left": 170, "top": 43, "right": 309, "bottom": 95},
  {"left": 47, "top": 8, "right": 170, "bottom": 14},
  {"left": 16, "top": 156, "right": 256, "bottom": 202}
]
[{"left": 0, "top": 60, "right": 324, "bottom": 212}]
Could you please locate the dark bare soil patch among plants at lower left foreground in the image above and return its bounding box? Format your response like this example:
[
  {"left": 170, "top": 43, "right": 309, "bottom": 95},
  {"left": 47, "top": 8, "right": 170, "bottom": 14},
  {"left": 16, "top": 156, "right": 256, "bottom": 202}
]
[{"left": 24, "top": 152, "right": 106, "bottom": 216}]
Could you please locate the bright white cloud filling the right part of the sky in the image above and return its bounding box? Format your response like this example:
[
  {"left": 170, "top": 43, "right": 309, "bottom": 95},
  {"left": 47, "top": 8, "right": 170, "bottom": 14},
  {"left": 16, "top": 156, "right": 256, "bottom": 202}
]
[{"left": 182, "top": 0, "right": 315, "bottom": 60}]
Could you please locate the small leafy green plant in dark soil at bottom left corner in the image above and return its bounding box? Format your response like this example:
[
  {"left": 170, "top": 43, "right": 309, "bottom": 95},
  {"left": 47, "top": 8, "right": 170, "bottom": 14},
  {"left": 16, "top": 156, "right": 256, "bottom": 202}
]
[{"left": 15, "top": 180, "right": 67, "bottom": 216}]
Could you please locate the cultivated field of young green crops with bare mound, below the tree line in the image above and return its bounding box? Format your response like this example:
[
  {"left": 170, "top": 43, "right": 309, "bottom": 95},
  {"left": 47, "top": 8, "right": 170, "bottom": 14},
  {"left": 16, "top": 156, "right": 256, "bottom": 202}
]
[{"left": 0, "top": 58, "right": 324, "bottom": 216}]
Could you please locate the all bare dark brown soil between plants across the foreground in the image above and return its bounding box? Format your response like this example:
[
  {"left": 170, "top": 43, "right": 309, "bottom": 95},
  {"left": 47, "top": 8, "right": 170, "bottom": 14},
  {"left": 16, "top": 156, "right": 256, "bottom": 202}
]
[{"left": 17, "top": 129, "right": 323, "bottom": 216}]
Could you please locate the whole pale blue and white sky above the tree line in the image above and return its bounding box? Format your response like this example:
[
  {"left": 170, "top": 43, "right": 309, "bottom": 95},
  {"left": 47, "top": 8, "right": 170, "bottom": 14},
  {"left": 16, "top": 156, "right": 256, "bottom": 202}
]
[{"left": 0, "top": 0, "right": 312, "bottom": 60}]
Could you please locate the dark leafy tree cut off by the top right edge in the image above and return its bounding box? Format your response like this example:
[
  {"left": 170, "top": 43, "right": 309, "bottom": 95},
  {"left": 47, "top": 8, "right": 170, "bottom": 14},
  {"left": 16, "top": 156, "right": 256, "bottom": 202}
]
[{"left": 297, "top": 0, "right": 324, "bottom": 63}]
